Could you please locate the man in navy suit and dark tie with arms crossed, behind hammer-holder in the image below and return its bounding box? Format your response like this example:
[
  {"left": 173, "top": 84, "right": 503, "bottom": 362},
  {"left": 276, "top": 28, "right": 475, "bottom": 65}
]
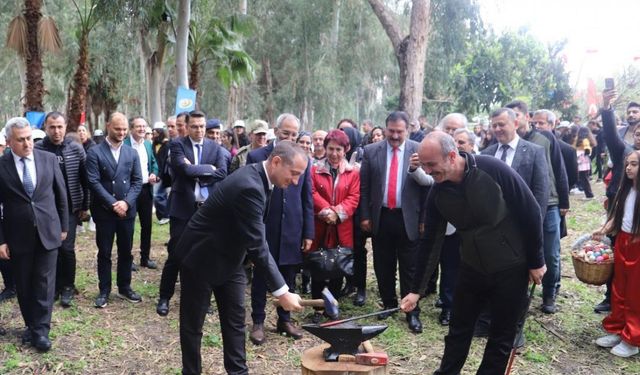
[{"left": 156, "top": 111, "right": 227, "bottom": 316}]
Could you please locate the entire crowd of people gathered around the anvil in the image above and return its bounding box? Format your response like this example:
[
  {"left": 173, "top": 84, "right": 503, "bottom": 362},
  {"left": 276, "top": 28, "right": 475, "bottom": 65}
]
[{"left": 0, "top": 91, "right": 640, "bottom": 374}]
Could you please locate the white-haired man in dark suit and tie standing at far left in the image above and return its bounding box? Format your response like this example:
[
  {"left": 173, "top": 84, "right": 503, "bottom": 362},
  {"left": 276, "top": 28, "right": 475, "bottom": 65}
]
[{"left": 0, "top": 117, "right": 69, "bottom": 351}]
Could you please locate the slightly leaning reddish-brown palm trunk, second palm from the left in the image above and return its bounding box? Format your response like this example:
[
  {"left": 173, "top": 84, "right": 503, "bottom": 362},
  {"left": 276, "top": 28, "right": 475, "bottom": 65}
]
[{"left": 67, "top": 31, "right": 89, "bottom": 132}]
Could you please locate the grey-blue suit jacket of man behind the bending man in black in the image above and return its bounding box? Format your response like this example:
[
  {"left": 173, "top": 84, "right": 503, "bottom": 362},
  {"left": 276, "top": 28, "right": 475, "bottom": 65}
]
[{"left": 482, "top": 138, "right": 550, "bottom": 217}]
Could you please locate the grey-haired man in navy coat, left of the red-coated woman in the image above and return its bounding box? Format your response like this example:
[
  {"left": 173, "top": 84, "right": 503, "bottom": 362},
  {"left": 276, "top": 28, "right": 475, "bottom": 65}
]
[{"left": 247, "top": 113, "right": 314, "bottom": 345}]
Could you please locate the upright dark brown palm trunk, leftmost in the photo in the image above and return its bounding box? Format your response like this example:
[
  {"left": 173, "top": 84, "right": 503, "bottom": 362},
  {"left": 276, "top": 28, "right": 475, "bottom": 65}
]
[{"left": 24, "top": 0, "right": 44, "bottom": 111}]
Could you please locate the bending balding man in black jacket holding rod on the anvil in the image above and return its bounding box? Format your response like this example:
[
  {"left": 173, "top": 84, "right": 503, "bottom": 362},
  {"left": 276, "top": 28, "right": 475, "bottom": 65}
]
[{"left": 401, "top": 131, "right": 546, "bottom": 374}]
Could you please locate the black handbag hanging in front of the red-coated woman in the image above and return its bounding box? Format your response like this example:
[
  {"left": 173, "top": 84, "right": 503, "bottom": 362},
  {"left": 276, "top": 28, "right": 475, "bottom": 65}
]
[{"left": 304, "top": 226, "right": 353, "bottom": 280}]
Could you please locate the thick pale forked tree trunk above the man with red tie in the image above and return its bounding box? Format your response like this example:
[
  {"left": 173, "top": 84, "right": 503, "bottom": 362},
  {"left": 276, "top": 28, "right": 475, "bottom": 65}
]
[{"left": 369, "top": 0, "right": 431, "bottom": 120}]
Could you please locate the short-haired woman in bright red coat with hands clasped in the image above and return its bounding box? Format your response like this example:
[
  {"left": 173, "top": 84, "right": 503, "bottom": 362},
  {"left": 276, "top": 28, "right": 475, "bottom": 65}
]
[{"left": 311, "top": 129, "right": 360, "bottom": 320}]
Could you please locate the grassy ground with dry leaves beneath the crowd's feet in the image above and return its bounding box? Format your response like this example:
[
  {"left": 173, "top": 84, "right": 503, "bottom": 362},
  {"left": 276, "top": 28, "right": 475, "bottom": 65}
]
[{"left": 0, "top": 183, "right": 640, "bottom": 375}]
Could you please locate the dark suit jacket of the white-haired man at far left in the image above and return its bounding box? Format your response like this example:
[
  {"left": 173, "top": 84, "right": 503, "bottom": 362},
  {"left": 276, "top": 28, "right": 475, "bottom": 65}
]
[{"left": 0, "top": 149, "right": 69, "bottom": 254}]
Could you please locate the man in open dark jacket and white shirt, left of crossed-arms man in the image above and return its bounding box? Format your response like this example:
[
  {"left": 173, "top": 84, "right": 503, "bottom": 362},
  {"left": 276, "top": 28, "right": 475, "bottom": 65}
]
[{"left": 124, "top": 116, "right": 158, "bottom": 271}]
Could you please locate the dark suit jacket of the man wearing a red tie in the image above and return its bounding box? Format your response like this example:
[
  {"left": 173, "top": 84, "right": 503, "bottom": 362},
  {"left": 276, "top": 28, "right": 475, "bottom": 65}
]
[{"left": 360, "top": 139, "right": 428, "bottom": 241}]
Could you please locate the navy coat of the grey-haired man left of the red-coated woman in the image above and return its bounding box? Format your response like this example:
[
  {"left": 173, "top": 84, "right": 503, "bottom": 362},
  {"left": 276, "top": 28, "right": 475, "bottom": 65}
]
[{"left": 247, "top": 142, "right": 315, "bottom": 265}]
